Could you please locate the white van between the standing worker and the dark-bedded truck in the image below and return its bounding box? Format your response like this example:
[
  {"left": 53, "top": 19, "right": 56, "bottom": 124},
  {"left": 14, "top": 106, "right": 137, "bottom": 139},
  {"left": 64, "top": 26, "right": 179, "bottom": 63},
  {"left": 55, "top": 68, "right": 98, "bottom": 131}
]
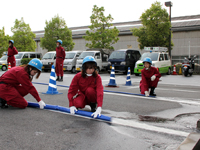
[{"left": 63, "top": 51, "right": 82, "bottom": 73}]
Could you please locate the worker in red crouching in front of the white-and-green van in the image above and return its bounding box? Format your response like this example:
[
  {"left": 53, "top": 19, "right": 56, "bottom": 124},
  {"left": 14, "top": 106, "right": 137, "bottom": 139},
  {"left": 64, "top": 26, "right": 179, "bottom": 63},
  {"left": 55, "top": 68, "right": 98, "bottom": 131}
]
[{"left": 140, "top": 57, "right": 161, "bottom": 96}]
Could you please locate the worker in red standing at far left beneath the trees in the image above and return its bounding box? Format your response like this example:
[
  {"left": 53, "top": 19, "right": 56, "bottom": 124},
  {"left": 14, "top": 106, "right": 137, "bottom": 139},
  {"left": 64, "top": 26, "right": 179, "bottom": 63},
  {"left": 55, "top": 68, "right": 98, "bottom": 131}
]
[{"left": 7, "top": 40, "right": 18, "bottom": 67}]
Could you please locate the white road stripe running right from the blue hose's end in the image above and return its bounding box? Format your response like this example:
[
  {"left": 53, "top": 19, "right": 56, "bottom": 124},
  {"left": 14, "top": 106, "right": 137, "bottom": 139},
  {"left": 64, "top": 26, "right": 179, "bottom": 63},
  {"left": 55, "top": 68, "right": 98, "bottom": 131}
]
[{"left": 112, "top": 118, "right": 189, "bottom": 137}]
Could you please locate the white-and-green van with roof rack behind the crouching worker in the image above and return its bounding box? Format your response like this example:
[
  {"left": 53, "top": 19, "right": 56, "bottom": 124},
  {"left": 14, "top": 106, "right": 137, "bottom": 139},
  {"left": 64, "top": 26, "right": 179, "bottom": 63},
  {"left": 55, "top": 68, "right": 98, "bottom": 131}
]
[{"left": 134, "top": 47, "right": 171, "bottom": 76}]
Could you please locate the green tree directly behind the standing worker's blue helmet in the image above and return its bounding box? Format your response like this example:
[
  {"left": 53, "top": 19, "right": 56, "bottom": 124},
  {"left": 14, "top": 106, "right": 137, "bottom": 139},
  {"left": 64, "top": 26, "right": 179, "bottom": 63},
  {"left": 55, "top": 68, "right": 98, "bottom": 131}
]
[{"left": 40, "top": 15, "right": 75, "bottom": 51}]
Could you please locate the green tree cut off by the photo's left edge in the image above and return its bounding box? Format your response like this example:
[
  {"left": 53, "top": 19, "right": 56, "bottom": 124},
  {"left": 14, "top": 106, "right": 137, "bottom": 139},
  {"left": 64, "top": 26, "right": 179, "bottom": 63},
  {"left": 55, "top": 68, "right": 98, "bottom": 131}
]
[{"left": 0, "top": 27, "right": 10, "bottom": 56}]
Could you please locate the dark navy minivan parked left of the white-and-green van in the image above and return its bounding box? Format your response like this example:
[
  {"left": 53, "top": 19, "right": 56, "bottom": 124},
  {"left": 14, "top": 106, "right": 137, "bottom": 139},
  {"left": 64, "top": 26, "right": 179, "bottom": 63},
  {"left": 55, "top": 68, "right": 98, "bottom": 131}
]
[{"left": 107, "top": 49, "right": 141, "bottom": 74}]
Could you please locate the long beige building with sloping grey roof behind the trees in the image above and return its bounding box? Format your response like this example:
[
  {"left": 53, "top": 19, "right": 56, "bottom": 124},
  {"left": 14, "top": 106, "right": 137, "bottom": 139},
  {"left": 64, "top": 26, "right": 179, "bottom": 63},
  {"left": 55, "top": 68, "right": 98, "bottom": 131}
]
[{"left": 34, "top": 15, "right": 200, "bottom": 63}]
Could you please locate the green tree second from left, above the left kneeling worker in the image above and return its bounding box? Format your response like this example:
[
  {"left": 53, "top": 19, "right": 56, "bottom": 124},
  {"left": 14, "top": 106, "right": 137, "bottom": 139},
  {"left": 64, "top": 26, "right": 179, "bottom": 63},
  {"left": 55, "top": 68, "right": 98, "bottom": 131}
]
[{"left": 11, "top": 18, "right": 36, "bottom": 51}]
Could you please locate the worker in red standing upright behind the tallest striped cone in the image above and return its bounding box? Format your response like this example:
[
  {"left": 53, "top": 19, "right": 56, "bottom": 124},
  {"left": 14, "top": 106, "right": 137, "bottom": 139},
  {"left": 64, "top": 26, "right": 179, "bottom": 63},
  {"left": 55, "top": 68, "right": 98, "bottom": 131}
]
[{"left": 56, "top": 40, "right": 65, "bottom": 81}]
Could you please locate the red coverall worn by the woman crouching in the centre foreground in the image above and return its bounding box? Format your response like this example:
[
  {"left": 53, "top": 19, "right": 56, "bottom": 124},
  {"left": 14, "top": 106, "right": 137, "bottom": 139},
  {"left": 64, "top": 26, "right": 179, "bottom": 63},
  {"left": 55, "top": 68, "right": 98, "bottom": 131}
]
[{"left": 68, "top": 72, "right": 103, "bottom": 108}]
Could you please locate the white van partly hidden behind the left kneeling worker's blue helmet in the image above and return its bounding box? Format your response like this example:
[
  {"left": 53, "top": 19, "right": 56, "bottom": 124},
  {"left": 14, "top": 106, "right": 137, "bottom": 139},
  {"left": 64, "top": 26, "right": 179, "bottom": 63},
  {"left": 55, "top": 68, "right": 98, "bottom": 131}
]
[{"left": 14, "top": 52, "right": 42, "bottom": 66}]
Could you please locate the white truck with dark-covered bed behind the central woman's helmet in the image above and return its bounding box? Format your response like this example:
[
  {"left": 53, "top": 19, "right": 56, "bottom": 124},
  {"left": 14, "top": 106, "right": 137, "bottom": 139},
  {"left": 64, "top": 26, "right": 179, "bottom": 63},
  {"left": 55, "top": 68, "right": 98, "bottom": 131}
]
[{"left": 76, "top": 48, "right": 114, "bottom": 72}]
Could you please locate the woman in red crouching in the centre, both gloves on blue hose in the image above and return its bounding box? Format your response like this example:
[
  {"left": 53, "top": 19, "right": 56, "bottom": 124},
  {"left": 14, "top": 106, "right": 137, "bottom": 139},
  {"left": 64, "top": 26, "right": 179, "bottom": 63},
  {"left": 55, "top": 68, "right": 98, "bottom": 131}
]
[{"left": 68, "top": 56, "right": 103, "bottom": 118}]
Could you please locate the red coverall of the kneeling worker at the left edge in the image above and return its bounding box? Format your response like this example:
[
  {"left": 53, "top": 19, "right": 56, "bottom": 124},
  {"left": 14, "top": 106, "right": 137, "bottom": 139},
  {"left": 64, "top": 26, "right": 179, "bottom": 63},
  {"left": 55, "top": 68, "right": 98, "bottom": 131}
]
[{"left": 0, "top": 67, "right": 41, "bottom": 108}]
